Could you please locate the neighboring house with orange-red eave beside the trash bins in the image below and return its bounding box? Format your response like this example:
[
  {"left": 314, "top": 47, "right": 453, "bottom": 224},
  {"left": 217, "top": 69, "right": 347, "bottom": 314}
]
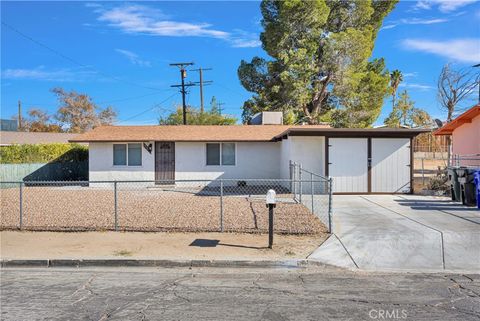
[{"left": 434, "top": 104, "right": 480, "bottom": 165}]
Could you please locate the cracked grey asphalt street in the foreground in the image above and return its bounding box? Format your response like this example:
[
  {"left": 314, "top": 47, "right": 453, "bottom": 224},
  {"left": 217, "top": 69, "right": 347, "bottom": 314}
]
[{"left": 0, "top": 268, "right": 480, "bottom": 321}]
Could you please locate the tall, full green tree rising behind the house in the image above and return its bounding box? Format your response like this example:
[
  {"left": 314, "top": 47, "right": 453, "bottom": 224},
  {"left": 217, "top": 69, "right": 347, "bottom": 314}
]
[{"left": 238, "top": 0, "right": 397, "bottom": 127}]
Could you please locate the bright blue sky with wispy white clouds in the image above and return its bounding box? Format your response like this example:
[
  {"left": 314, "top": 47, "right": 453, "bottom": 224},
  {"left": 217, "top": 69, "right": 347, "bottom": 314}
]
[{"left": 1, "top": 0, "right": 480, "bottom": 125}]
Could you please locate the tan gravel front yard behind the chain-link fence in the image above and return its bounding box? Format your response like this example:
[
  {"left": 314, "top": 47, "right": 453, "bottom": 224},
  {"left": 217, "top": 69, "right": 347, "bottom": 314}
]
[{"left": 0, "top": 186, "right": 326, "bottom": 234}]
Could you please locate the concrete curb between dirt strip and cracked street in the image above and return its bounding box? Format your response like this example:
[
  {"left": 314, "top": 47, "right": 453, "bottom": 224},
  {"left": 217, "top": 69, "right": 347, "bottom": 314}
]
[{"left": 0, "top": 259, "right": 327, "bottom": 269}]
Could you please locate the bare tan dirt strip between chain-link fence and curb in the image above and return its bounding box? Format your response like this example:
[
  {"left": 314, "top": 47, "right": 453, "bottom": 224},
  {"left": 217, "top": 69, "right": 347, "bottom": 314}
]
[{"left": 0, "top": 231, "right": 326, "bottom": 261}]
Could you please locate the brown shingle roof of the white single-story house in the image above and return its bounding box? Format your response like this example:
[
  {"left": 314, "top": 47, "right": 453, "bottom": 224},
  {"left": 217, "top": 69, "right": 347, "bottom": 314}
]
[{"left": 70, "top": 125, "right": 328, "bottom": 142}]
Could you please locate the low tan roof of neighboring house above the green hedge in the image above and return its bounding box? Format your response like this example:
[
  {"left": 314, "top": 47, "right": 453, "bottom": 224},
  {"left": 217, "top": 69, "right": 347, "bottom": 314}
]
[{"left": 0, "top": 131, "right": 77, "bottom": 146}]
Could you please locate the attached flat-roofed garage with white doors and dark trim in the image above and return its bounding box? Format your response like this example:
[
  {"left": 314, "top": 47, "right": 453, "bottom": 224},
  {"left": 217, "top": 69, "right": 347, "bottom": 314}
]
[{"left": 277, "top": 127, "right": 428, "bottom": 194}]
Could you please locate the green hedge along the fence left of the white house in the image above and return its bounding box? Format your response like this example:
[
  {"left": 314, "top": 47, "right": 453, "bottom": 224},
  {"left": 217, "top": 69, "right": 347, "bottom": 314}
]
[{"left": 0, "top": 143, "right": 88, "bottom": 164}]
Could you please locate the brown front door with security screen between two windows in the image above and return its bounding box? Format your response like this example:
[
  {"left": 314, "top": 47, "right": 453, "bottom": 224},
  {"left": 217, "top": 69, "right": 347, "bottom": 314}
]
[{"left": 155, "top": 142, "right": 175, "bottom": 184}]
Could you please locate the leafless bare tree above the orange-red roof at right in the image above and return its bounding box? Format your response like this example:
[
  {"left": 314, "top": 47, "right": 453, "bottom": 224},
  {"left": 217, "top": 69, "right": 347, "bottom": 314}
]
[{"left": 438, "top": 64, "right": 480, "bottom": 122}]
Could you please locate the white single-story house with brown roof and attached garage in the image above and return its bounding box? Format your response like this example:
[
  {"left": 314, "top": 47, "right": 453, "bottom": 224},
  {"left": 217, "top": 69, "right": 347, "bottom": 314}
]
[{"left": 70, "top": 125, "right": 424, "bottom": 193}]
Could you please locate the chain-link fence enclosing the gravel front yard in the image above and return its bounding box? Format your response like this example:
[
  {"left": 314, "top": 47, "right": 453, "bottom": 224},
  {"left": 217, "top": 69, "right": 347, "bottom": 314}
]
[{"left": 0, "top": 177, "right": 330, "bottom": 234}]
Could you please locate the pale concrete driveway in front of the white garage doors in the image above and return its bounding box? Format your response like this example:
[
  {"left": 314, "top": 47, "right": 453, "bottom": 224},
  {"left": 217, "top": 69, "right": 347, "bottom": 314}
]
[{"left": 309, "top": 195, "right": 480, "bottom": 272}]
